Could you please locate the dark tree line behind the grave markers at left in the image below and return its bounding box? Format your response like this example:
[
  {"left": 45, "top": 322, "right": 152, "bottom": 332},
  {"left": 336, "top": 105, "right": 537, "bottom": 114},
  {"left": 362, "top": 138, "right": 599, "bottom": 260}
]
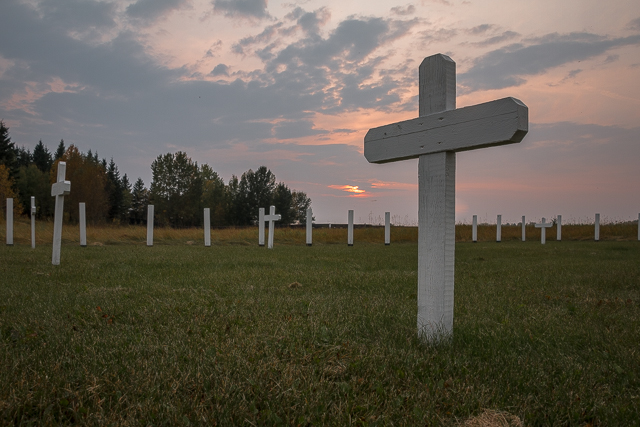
[{"left": 0, "top": 121, "right": 311, "bottom": 227}]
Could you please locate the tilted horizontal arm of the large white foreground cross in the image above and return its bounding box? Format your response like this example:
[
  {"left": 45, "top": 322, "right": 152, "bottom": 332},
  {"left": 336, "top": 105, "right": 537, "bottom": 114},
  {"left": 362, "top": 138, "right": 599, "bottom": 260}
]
[{"left": 364, "top": 98, "right": 529, "bottom": 163}]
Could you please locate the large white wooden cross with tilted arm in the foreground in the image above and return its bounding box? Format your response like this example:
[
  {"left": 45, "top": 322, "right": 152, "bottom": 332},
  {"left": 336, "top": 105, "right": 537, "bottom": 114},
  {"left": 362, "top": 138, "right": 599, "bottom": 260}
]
[{"left": 364, "top": 54, "right": 529, "bottom": 340}]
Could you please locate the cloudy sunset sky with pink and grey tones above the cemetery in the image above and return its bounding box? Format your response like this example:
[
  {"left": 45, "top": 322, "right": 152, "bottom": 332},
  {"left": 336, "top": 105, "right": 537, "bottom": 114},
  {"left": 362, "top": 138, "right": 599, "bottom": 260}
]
[{"left": 0, "top": 0, "right": 640, "bottom": 225}]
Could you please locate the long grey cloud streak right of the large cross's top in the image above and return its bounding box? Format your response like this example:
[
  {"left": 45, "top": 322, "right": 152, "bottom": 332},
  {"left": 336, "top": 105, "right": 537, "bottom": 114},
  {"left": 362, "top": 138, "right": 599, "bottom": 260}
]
[{"left": 458, "top": 33, "right": 640, "bottom": 93}]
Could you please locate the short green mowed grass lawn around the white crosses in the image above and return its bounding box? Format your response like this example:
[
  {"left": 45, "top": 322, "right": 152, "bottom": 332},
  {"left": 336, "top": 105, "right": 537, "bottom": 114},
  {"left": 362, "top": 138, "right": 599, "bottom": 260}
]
[{"left": 0, "top": 239, "right": 640, "bottom": 426}]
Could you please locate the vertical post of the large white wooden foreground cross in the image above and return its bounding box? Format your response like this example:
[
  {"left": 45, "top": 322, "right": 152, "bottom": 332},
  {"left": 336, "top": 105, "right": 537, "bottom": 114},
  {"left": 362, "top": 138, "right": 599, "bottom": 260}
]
[{"left": 418, "top": 55, "right": 456, "bottom": 340}]
